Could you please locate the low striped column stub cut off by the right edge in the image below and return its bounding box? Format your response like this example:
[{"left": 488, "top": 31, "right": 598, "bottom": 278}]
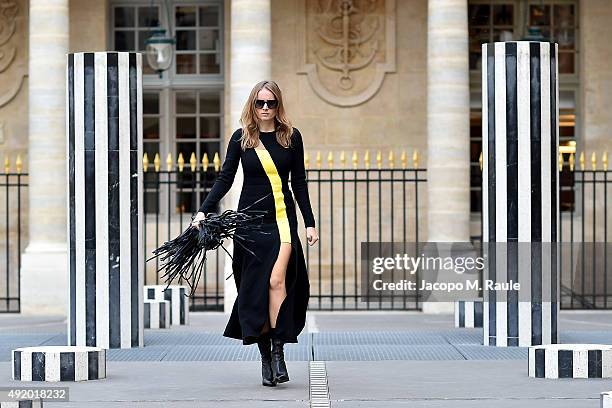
[{"left": 528, "top": 344, "right": 612, "bottom": 378}]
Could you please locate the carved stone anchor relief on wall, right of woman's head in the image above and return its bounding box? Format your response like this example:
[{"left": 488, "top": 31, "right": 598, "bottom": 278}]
[{"left": 298, "top": 0, "right": 395, "bottom": 106}]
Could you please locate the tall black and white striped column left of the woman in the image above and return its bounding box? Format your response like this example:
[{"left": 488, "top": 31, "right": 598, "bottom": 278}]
[{"left": 66, "top": 52, "right": 144, "bottom": 348}]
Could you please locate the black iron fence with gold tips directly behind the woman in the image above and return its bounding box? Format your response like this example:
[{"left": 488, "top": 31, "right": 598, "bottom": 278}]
[{"left": 144, "top": 158, "right": 426, "bottom": 310}]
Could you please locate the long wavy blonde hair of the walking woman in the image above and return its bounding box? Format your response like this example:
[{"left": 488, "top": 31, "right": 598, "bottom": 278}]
[{"left": 240, "top": 81, "right": 293, "bottom": 150}]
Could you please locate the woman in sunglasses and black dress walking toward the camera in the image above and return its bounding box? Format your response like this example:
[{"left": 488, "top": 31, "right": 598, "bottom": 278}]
[{"left": 192, "top": 81, "right": 319, "bottom": 386}]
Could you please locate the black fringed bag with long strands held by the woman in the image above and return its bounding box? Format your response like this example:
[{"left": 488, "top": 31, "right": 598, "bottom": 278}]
[{"left": 147, "top": 193, "right": 271, "bottom": 296}]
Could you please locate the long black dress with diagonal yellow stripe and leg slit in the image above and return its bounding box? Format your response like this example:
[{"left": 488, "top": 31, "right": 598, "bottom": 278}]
[{"left": 200, "top": 128, "right": 315, "bottom": 344}]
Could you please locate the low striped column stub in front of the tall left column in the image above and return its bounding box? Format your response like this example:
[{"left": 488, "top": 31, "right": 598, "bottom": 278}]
[{"left": 12, "top": 346, "right": 106, "bottom": 382}]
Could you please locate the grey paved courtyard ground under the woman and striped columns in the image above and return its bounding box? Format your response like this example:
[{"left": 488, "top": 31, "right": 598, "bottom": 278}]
[{"left": 0, "top": 311, "right": 612, "bottom": 408}]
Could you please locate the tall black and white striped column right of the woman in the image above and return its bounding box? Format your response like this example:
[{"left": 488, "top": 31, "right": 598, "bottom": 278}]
[{"left": 482, "top": 41, "right": 559, "bottom": 347}]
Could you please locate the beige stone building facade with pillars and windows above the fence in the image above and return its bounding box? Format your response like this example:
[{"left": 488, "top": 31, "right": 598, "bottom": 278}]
[{"left": 0, "top": 0, "right": 612, "bottom": 313}]
